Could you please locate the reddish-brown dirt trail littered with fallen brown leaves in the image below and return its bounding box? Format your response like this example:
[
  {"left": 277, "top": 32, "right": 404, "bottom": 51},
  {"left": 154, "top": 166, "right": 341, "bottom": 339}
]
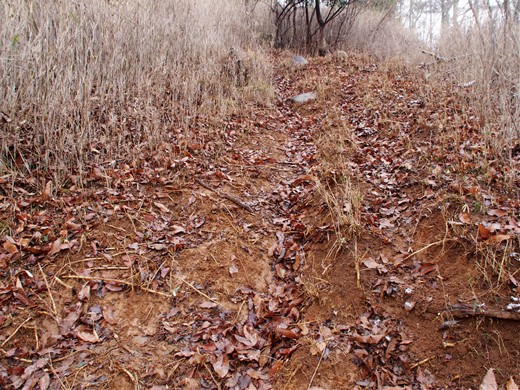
[{"left": 0, "top": 56, "right": 520, "bottom": 389}]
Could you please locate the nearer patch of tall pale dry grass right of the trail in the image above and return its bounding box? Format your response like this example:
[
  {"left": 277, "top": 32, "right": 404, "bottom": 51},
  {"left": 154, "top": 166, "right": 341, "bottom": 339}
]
[{"left": 422, "top": 20, "right": 520, "bottom": 189}]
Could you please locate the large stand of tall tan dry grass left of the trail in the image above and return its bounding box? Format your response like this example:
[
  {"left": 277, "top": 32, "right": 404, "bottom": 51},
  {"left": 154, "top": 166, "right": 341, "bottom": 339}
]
[{"left": 0, "top": 0, "right": 269, "bottom": 183}]
